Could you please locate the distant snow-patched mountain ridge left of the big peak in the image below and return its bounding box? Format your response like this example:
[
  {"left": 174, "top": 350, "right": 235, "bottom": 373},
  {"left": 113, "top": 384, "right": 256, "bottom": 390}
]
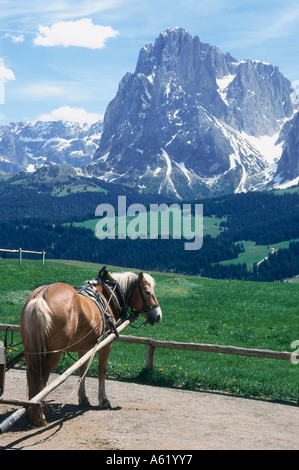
[{"left": 0, "top": 121, "right": 103, "bottom": 173}]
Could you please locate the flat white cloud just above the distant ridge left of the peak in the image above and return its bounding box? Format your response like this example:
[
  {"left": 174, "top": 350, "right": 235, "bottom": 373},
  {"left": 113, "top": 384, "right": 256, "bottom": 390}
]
[{"left": 38, "top": 106, "right": 103, "bottom": 124}]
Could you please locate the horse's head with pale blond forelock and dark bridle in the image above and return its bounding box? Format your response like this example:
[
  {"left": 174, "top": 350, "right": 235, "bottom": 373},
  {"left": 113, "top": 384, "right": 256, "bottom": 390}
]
[{"left": 128, "top": 273, "right": 162, "bottom": 325}]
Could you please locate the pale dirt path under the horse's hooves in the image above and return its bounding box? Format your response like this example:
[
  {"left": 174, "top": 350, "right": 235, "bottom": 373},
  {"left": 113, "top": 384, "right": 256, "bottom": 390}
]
[{"left": 0, "top": 369, "right": 299, "bottom": 450}]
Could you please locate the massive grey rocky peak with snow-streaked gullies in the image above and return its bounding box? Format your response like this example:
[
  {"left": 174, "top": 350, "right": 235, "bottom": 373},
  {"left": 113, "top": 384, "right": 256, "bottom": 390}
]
[{"left": 90, "top": 28, "right": 294, "bottom": 198}]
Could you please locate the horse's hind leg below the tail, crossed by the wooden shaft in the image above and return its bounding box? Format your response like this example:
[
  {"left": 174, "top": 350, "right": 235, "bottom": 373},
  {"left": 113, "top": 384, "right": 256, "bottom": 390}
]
[{"left": 28, "top": 353, "right": 61, "bottom": 427}]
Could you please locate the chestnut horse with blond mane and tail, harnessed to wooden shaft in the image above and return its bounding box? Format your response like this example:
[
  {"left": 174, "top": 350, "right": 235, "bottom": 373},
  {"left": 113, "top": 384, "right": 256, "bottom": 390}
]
[{"left": 20, "top": 272, "right": 162, "bottom": 426}]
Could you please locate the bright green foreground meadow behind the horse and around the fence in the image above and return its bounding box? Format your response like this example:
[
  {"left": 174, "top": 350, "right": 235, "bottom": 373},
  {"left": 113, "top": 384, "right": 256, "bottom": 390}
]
[{"left": 0, "top": 259, "right": 299, "bottom": 403}]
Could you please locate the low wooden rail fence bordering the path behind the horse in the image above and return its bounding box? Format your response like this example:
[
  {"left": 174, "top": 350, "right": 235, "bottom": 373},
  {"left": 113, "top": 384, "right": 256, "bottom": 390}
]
[{"left": 0, "top": 323, "right": 299, "bottom": 369}]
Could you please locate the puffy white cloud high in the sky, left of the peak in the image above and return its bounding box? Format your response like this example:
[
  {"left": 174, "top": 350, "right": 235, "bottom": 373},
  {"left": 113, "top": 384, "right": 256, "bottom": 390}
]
[{"left": 33, "top": 18, "right": 119, "bottom": 49}]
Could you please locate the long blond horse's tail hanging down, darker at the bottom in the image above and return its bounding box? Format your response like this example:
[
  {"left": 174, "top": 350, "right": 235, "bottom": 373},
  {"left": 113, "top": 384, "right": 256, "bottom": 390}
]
[{"left": 23, "top": 297, "right": 52, "bottom": 399}]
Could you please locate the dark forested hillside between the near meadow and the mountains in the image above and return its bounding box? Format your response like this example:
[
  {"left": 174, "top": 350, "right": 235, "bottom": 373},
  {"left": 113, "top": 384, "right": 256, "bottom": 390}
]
[{"left": 0, "top": 173, "right": 299, "bottom": 281}]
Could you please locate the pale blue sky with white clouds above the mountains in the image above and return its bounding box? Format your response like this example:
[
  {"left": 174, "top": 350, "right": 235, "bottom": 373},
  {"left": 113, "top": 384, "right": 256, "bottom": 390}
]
[{"left": 0, "top": 0, "right": 299, "bottom": 124}]
